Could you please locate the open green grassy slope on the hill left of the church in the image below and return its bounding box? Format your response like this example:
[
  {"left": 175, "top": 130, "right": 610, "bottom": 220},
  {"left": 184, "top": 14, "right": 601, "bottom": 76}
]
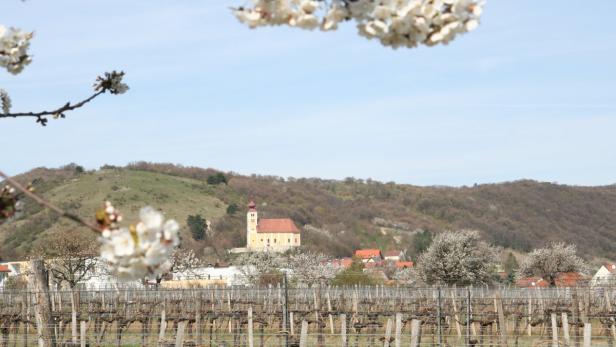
[{"left": 0, "top": 170, "right": 227, "bottom": 253}]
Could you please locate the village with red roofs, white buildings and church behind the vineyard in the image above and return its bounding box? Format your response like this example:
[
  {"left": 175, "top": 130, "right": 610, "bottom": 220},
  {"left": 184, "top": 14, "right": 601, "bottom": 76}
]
[{"left": 0, "top": 201, "right": 616, "bottom": 290}]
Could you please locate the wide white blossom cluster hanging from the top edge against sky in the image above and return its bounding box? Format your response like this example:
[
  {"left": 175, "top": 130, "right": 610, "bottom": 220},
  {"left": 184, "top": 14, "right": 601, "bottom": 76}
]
[{"left": 234, "top": 0, "right": 485, "bottom": 48}]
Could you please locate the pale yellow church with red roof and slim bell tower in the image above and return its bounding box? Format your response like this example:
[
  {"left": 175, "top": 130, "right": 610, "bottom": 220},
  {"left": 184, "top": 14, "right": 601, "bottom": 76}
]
[{"left": 246, "top": 201, "right": 301, "bottom": 252}]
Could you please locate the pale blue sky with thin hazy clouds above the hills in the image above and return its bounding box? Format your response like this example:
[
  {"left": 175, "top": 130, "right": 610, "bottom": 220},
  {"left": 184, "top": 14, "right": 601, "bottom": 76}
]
[{"left": 0, "top": 0, "right": 616, "bottom": 185}]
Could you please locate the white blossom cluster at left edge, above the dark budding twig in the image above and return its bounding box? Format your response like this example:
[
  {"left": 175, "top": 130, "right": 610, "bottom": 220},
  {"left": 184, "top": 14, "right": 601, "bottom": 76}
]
[{"left": 0, "top": 25, "right": 33, "bottom": 75}]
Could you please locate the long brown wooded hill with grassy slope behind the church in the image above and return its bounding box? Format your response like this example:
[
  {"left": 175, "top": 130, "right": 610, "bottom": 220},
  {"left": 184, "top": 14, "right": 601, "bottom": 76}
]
[{"left": 0, "top": 162, "right": 616, "bottom": 259}]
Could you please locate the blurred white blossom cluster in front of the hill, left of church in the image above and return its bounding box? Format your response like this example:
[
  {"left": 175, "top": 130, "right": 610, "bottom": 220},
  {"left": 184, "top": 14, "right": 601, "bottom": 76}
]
[{"left": 96, "top": 202, "right": 180, "bottom": 281}]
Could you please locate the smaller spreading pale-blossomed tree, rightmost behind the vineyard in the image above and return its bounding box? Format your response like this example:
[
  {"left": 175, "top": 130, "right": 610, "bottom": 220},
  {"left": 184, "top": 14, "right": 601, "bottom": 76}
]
[{"left": 518, "top": 242, "right": 587, "bottom": 286}]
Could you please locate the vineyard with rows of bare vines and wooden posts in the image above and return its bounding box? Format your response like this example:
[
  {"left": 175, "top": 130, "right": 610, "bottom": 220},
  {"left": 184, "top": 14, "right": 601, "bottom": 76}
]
[{"left": 0, "top": 285, "right": 616, "bottom": 347}]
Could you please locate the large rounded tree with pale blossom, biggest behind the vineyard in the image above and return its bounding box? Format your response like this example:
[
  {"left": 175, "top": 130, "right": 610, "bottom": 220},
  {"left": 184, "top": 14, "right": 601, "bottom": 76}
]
[{"left": 417, "top": 230, "right": 498, "bottom": 285}]
